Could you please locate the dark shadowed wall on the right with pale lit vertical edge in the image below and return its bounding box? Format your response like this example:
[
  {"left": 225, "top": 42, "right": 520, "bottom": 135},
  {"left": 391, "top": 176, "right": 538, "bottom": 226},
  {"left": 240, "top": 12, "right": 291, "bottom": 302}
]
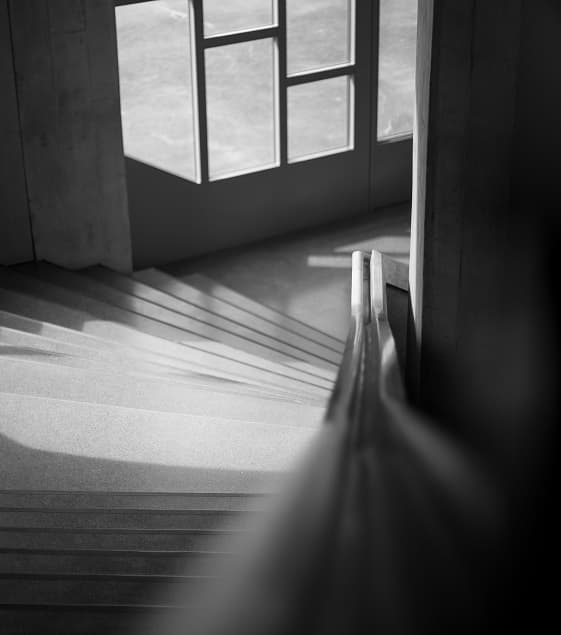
[{"left": 408, "top": 0, "right": 561, "bottom": 471}]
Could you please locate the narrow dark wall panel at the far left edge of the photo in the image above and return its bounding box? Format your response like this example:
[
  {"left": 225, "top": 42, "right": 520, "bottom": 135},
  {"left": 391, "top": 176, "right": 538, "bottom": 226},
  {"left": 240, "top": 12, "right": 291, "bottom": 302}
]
[{"left": 0, "top": 0, "right": 33, "bottom": 265}]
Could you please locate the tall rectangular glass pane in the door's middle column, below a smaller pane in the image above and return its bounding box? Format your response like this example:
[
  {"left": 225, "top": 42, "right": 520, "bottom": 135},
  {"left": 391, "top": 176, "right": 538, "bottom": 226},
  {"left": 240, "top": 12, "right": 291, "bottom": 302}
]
[{"left": 205, "top": 38, "right": 277, "bottom": 178}]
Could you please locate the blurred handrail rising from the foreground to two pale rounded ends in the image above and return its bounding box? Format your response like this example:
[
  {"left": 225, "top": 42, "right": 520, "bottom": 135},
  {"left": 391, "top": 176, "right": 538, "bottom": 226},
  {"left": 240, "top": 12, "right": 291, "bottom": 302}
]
[{"left": 182, "top": 252, "right": 497, "bottom": 635}]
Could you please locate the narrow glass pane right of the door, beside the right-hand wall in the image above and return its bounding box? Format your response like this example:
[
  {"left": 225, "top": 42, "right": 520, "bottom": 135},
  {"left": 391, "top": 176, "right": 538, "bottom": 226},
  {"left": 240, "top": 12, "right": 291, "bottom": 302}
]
[{"left": 378, "top": 0, "right": 417, "bottom": 139}]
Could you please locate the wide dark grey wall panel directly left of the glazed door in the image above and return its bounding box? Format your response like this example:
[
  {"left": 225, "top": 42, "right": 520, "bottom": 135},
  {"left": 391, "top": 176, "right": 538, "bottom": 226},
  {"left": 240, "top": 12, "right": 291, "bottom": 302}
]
[{"left": 10, "top": 0, "right": 132, "bottom": 270}]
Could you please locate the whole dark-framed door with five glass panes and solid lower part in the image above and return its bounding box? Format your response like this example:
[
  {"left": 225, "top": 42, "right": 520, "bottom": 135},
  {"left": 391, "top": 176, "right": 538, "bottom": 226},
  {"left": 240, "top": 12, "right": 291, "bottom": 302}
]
[{"left": 112, "top": 0, "right": 411, "bottom": 267}]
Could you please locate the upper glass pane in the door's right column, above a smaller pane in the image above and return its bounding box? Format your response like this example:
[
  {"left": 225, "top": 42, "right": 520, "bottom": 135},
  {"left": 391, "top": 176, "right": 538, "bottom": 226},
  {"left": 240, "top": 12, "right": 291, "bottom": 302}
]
[{"left": 286, "top": 0, "right": 354, "bottom": 75}]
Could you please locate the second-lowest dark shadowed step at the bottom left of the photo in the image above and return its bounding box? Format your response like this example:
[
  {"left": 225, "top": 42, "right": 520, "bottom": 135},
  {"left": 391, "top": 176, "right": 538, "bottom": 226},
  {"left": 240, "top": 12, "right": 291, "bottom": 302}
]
[{"left": 0, "top": 573, "right": 210, "bottom": 605}]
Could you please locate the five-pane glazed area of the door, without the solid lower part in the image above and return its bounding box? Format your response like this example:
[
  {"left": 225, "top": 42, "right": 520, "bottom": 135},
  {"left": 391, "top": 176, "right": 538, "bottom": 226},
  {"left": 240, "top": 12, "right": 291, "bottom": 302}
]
[{"left": 116, "top": 0, "right": 355, "bottom": 183}]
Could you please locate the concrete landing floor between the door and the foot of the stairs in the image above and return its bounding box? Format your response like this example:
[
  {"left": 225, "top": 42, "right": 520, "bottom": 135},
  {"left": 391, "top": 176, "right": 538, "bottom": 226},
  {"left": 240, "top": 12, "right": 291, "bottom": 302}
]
[{"left": 166, "top": 203, "right": 411, "bottom": 339}]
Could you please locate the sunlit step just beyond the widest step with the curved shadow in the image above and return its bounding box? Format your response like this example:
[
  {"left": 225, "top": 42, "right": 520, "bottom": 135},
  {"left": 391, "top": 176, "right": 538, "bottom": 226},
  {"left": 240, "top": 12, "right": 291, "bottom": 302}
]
[{"left": 0, "top": 360, "right": 323, "bottom": 426}]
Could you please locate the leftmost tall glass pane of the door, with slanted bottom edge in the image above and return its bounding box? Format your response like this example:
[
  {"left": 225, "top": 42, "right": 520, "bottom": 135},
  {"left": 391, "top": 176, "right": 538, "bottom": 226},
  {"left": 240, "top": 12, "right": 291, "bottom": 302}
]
[{"left": 115, "top": 0, "right": 198, "bottom": 181}]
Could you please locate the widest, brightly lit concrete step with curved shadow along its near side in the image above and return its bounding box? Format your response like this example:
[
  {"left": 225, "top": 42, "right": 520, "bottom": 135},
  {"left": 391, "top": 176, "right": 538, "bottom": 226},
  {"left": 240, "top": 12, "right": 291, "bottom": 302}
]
[{"left": 0, "top": 393, "right": 317, "bottom": 493}]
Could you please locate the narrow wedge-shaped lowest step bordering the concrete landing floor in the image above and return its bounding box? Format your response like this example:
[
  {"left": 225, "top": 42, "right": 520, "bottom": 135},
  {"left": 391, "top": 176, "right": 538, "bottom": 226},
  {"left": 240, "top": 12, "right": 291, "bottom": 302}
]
[{"left": 181, "top": 273, "right": 345, "bottom": 355}]
